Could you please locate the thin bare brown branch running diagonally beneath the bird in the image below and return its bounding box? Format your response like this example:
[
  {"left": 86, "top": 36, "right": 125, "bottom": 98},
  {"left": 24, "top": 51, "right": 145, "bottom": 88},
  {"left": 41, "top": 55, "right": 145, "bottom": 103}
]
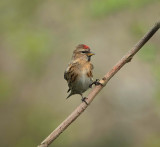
[{"left": 38, "top": 22, "right": 160, "bottom": 147}]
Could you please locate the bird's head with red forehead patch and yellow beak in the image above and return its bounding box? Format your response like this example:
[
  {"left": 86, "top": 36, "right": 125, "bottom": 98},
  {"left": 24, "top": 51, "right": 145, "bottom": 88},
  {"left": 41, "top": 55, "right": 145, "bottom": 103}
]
[{"left": 72, "top": 44, "right": 95, "bottom": 61}]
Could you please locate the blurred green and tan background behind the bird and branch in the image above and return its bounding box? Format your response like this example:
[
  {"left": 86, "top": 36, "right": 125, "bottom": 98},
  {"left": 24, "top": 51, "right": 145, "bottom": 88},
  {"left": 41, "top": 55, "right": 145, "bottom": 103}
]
[{"left": 0, "top": 0, "right": 160, "bottom": 147}]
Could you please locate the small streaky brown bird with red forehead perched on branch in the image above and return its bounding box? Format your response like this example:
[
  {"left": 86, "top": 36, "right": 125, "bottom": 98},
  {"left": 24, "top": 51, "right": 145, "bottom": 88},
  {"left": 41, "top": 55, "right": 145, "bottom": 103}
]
[{"left": 64, "top": 44, "right": 97, "bottom": 104}]
